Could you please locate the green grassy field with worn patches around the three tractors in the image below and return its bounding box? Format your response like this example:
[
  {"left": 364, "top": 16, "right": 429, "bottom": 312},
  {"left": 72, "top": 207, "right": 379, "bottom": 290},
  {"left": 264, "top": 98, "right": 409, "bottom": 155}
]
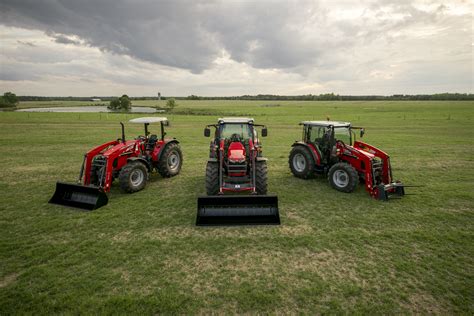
[{"left": 0, "top": 101, "right": 474, "bottom": 315}]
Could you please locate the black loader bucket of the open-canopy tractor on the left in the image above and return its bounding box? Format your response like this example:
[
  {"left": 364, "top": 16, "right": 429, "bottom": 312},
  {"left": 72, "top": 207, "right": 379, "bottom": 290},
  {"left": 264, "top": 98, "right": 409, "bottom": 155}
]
[{"left": 49, "top": 182, "right": 109, "bottom": 211}]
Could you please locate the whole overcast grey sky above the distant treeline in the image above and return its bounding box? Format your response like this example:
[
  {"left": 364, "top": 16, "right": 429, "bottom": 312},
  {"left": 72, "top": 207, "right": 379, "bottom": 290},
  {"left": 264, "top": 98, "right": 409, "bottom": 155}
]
[{"left": 0, "top": 0, "right": 474, "bottom": 96}]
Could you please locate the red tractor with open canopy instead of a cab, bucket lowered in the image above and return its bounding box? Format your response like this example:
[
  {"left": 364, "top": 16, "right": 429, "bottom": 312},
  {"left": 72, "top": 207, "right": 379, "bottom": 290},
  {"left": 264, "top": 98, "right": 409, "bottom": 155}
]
[{"left": 49, "top": 117, "right": 183, "bottom": 210}]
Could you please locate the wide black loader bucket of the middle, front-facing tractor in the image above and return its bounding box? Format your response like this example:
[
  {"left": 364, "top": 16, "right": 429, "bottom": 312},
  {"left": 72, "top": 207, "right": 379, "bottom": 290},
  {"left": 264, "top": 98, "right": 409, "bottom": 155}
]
[{"left": 196, "top": 195, "right": 280, "bottom": 226}]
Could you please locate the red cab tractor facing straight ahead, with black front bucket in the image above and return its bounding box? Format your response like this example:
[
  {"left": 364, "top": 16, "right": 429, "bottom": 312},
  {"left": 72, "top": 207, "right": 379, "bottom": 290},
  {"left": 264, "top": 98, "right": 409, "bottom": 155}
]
[{"left": 196, "top": 117, "right": 280, "bottom": 225}]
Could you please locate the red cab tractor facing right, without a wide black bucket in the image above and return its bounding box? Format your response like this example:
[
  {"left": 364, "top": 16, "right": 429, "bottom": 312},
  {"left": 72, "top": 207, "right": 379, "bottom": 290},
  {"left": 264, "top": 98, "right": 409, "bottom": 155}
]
[{"left": 289, "top": 121, "right": 405, "bottom": 201}]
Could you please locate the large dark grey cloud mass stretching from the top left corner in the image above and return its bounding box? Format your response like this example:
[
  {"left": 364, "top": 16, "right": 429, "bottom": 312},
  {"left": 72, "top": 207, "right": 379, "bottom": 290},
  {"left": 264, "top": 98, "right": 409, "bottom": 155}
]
[{"left": 0, "top": 0, "right": 347, "bottom": 73}]
